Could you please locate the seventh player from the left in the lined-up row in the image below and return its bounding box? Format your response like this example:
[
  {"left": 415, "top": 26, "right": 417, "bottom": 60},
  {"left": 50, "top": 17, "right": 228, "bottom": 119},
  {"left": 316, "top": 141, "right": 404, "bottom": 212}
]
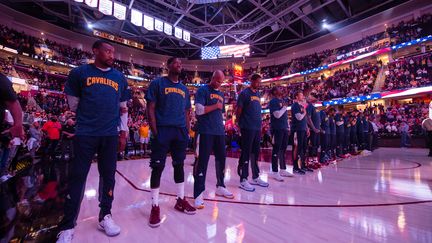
[{"left": 306, "top": 93, "right": 321, "bottom": 168}]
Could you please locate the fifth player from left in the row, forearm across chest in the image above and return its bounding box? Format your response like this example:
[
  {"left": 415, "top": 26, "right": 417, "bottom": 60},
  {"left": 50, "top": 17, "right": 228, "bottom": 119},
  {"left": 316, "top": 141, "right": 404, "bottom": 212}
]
[{"left": 269, "top": 86, "right": 293, "bottom": 181}]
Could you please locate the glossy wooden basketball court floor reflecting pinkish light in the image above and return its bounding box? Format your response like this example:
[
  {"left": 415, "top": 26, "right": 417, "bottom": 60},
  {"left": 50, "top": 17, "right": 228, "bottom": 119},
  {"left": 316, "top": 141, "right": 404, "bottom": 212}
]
[{"left": 74, "top": 148, "right": 432, "bottom": 243}]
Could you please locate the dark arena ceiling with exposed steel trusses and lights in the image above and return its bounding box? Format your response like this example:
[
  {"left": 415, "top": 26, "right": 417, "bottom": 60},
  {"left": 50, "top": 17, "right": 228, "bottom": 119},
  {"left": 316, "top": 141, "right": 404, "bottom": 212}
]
[{"left": 0, "top": 0, "right": 407, "bottom": 59}]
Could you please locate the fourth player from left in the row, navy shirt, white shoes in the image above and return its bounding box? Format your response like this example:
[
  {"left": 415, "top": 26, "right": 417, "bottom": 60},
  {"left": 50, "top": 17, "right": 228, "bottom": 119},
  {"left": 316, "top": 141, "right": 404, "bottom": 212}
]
[{"left": 236, "top": 74, "right": 269, "bottom": 192}]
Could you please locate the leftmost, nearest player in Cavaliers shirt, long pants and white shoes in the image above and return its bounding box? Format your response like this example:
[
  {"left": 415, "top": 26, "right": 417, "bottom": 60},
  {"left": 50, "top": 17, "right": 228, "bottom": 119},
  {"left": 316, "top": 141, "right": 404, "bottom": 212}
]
[{"left": 57, "top": 40, "right": 129, "bottom": 242}]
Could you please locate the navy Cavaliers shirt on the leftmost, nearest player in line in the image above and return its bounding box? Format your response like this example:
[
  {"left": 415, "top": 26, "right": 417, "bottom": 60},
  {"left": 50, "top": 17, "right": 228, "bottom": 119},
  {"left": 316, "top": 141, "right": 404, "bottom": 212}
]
[{"left": 65, "top": 64, "right": 129, "bottom": 136}]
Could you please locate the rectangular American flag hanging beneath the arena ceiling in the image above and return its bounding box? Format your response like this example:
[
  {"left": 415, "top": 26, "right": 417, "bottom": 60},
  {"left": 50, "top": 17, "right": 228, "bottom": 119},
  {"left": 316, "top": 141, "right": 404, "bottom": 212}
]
[{"left": 201, "top": 45, "right": 250, "bottom": 59}]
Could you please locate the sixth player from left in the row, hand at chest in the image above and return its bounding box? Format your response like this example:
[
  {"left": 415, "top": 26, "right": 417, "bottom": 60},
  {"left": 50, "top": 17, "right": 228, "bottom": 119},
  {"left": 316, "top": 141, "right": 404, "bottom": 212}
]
[{"left": 291, "top": 91, "right": 313, "bottom": 175}]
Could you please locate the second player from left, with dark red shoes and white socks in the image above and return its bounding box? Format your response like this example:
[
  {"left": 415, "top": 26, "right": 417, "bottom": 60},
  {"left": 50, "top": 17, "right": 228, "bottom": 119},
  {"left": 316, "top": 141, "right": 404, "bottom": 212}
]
[{"left": 145, "top": 57, "right": 196, "bottom": 227}]
